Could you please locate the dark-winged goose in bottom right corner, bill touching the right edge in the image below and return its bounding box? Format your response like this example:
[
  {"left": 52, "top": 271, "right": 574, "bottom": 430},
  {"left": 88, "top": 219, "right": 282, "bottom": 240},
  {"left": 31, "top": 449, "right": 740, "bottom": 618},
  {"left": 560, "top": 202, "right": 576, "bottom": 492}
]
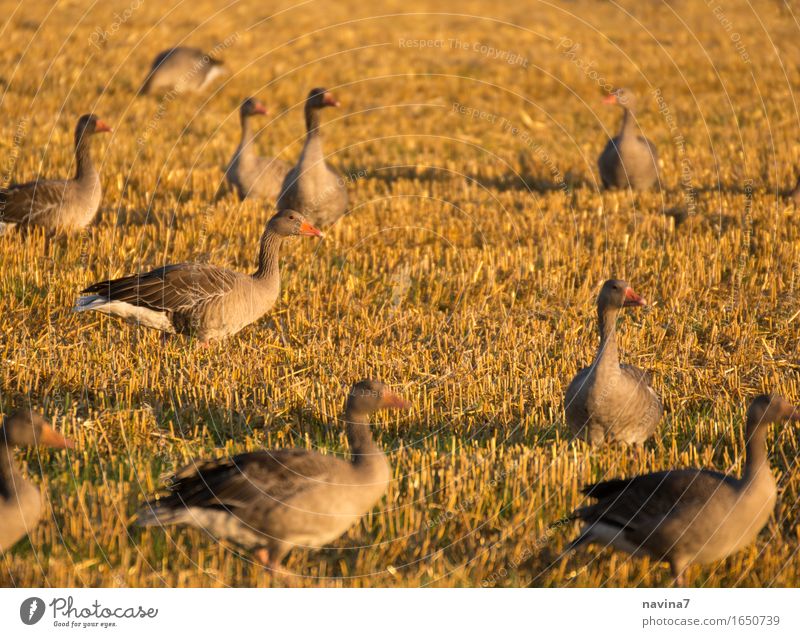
[{"left": 564, "top": 395, "right": 800, "bottom": 585}]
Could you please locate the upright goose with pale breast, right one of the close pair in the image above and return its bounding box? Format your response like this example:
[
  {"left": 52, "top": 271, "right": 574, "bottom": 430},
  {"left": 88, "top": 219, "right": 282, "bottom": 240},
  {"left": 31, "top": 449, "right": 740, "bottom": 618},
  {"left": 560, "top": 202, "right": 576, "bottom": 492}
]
[{"left": 278, "top": 88, "right": 348, "bottom": 226}]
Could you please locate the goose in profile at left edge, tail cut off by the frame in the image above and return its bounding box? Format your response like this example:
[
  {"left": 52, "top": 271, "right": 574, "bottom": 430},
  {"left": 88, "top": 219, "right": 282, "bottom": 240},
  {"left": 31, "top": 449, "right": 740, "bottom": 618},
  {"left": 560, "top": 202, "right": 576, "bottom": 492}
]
[{"left": 0, "top": 115, "right": 111, "bottom": 234}]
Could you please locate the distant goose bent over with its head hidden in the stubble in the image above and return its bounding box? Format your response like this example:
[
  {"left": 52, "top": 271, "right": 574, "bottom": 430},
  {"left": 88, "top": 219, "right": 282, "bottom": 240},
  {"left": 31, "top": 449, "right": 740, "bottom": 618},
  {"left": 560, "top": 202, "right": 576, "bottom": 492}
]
[{"left": 139, "top": 46, "right": 225, "bottom": 95}]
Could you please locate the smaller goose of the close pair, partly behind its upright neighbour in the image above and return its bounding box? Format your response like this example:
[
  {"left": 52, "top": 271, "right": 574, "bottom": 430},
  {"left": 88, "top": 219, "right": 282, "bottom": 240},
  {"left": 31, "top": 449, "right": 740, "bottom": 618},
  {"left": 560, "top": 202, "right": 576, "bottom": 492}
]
[{"left": 225, "top": 97, "right": 290, "bottom": 200}]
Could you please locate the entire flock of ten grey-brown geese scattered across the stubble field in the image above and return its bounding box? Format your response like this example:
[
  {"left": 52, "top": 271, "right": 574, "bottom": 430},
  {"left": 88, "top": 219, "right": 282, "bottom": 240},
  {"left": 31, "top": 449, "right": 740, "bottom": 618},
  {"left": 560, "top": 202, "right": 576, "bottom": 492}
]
[{"left": 0, "top": 47, "right": 800, "bottom": 584}]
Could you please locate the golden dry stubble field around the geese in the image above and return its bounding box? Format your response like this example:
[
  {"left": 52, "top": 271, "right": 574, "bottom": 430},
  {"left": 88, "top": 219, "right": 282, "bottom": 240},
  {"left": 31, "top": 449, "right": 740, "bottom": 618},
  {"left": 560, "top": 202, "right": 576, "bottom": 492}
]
[{"left": 0, "top": 0, "right": 800, "bottom": 586}]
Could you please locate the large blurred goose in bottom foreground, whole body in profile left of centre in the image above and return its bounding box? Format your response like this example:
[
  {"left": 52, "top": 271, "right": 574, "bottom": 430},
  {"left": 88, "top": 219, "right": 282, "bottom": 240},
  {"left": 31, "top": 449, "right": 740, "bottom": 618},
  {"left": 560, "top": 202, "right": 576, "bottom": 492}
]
[{"left": 137, "top": 380, "right": 410, "bottom": 569}]
